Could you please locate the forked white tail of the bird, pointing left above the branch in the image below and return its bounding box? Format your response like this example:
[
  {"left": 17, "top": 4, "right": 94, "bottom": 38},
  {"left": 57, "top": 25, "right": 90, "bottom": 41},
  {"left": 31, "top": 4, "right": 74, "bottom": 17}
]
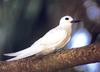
[{"left": 4, "top": 47, "right": 42, "bottom": 61}]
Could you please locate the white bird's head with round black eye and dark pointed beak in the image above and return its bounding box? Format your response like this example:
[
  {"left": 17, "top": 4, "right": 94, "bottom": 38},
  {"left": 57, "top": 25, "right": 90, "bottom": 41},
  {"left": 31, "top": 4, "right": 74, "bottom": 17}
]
[{"left": 60, "top": 16, "right": 80, "bottom": 26}]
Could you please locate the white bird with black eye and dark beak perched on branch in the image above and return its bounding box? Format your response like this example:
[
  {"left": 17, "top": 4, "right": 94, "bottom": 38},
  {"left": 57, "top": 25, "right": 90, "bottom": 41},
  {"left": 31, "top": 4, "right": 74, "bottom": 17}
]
[{"left": 4, "top": 16, "right": 80, "bottom": 61}]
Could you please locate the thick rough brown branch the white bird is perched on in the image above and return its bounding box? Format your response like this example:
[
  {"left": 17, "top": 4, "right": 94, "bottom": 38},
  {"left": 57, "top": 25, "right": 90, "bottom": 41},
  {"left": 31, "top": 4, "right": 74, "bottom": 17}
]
[{"left": 0, "top": 44, "right": 100, "bottom": 72}]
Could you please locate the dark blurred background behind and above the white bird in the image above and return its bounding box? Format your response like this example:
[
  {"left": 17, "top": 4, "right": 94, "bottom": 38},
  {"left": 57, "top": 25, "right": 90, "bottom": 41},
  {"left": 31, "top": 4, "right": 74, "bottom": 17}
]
[{"left": 0, "top": 0, "right": 100, "bottom": 72}]
